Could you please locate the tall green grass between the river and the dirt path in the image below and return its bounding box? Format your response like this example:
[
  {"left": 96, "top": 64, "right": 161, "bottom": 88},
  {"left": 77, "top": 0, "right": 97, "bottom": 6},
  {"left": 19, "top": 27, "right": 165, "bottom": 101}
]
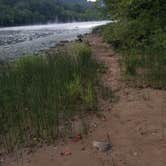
[{"left": 0, "top": 44, "right": 97, "bottom": 151}]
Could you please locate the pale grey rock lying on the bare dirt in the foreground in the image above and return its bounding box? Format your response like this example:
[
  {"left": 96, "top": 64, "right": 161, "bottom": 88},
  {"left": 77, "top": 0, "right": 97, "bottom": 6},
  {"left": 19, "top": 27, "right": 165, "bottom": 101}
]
[{"left": 93, "top": 141, "right": 112, "bottom": 152}]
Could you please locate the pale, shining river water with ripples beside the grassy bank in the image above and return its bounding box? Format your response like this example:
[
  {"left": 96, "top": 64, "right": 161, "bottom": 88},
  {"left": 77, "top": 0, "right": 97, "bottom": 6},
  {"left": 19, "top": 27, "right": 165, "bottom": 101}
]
[{"left": 0, "top": 21, "right": 110, "bottom": 60}]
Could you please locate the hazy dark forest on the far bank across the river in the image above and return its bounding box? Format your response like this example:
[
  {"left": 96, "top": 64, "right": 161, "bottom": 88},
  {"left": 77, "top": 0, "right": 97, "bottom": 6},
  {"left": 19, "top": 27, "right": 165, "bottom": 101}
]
[{"left": 0, "top": 0, "right": 105, "bottom": 26}]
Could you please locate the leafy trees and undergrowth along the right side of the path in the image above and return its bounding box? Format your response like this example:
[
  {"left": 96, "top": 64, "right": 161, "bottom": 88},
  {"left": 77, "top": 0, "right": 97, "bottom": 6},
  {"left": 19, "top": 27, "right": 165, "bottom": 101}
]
[{"left": 101, "top": 0, "right": 166, "bottom": 87}]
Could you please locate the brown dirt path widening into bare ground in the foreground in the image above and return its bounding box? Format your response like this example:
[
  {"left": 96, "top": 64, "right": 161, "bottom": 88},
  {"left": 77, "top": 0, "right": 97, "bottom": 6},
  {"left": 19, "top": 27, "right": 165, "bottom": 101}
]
[{"left": 5, "top": 35, "right": 166, "bottom": 166}]
